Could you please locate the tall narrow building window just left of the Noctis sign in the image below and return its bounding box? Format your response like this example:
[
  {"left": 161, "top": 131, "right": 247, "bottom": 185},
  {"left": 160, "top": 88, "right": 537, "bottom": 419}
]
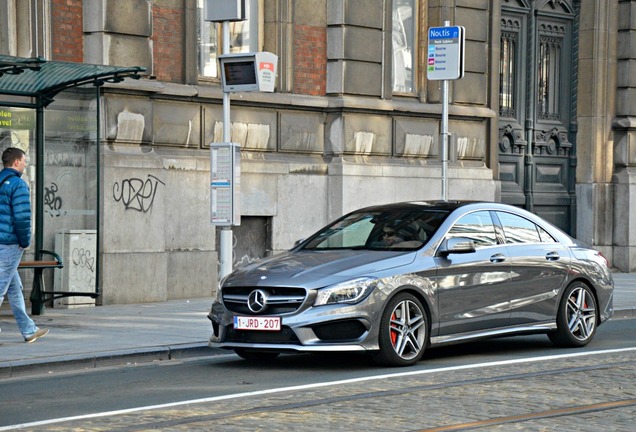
[{"left": 393, "top": 0, "right": 417, "bottom": 93}]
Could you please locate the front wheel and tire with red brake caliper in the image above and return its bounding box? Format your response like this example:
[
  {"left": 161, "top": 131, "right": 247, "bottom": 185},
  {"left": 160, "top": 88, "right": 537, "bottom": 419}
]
[{"left": 374, "top": 293, "right": 428, "bottom": 366}]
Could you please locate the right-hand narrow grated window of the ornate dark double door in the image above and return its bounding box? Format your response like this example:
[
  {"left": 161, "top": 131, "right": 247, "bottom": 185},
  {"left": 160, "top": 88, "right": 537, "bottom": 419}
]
[{"left": 537, "top": 36, "right": 562, "bottom": 120}]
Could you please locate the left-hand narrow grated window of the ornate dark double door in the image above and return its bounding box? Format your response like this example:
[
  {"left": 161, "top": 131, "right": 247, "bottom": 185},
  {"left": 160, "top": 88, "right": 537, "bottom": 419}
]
[{"left": 499, "top": 32, "right": 518, "bottom": 118}]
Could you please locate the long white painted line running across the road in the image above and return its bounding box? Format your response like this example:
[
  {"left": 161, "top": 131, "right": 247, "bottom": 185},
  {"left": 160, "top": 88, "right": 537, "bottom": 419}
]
[{"left": 0, "top": 347, "right": 636, "bottom": 431}]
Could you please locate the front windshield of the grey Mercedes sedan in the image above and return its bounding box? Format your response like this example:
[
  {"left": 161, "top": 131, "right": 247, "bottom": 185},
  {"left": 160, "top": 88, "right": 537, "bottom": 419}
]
[{"left": 302, "top": 209, "right": 448, "bottom": 250}]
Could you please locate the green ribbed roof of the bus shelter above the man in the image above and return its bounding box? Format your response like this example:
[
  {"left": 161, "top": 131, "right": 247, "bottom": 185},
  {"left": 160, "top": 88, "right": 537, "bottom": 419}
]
[{"left": 0, "top": 55, "right": 146, "bottom": 106}]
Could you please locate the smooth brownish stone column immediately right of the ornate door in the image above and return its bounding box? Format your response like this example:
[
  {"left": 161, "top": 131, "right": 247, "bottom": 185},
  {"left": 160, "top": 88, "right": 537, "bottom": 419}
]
[{"left": 576, "top": 0, "right": 617, "bottom": 260}]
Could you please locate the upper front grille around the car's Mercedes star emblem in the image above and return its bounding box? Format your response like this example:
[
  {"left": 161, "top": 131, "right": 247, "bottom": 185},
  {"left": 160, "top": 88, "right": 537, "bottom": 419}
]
[{"left": 223, "top": 287, "right": 307, "bottom": 315}]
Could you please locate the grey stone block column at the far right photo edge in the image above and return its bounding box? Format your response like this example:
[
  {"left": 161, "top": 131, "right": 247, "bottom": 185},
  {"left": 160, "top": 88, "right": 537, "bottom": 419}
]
[{"left": 612, "top": 0, "right": 636, "bottom": 272}]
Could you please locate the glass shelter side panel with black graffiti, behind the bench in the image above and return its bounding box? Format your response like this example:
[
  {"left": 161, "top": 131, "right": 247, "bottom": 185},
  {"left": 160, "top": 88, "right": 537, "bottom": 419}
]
[{"left": 43, "top": 87, "right": 99, "bottom": 307}]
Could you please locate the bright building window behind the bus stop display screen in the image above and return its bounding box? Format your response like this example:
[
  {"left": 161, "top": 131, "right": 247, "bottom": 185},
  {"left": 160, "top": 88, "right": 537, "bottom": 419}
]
[{"left": 197, "top": 0, "right": 262, "bottom": 78}]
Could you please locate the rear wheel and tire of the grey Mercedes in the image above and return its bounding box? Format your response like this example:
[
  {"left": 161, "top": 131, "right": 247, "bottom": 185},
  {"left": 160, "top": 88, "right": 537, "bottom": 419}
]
[{"left": 548, "top": 282, "right": 598, "bottom": 347}]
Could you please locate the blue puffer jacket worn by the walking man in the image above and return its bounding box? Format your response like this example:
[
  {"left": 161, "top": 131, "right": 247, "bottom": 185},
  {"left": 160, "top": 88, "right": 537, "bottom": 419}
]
[{"left": 0, "top": 168, "right": 31, "bottom": 248}]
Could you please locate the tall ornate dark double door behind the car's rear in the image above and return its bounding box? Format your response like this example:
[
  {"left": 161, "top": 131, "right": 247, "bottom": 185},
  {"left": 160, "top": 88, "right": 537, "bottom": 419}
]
[{"left": 499, "top": 0, "right": 578, "bottom": 235}]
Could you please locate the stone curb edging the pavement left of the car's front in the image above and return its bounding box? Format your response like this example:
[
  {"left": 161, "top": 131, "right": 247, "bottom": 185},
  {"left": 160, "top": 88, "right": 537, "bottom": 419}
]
[{"left": 0, "top": 342, "right": 220, "bottom": 379}]
